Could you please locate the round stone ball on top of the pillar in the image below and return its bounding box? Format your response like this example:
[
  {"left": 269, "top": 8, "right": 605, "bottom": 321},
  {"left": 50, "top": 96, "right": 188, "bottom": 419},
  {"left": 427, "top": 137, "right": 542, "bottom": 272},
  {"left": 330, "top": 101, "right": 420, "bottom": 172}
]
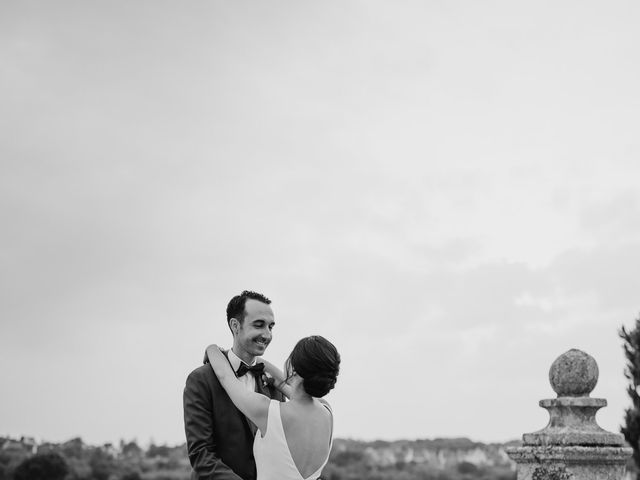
[{"left": 549, "top": 348, "right": 599, "bottom": 397}]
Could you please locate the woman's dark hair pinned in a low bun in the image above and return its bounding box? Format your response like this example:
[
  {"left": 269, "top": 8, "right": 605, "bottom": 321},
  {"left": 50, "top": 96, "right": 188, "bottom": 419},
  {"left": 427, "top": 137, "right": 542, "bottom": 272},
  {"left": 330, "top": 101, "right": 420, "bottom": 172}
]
[{"left": 288, "top": 335, "right": 340, "bottom": 398}]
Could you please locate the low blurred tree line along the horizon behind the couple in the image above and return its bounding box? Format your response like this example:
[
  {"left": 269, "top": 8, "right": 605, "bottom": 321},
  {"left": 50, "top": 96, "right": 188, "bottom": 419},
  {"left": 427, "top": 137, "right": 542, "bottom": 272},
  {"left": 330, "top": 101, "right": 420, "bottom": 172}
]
[{"left": 0, "top": 438, "right": 515, "bottom": 480}]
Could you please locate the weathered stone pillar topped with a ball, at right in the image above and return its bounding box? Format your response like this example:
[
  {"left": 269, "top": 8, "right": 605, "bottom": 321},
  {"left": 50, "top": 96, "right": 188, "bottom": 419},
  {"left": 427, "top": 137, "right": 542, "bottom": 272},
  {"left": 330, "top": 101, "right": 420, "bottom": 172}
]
[{"left": 507, "top": 349, "right": 632, "bottom": 480}]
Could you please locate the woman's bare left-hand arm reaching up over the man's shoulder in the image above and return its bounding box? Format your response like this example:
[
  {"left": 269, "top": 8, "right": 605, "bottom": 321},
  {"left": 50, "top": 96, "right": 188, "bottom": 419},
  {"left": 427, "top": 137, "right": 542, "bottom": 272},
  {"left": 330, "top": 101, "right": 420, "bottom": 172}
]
[{"left": 207, "top": 345, "right": 269, "bottom": 433}]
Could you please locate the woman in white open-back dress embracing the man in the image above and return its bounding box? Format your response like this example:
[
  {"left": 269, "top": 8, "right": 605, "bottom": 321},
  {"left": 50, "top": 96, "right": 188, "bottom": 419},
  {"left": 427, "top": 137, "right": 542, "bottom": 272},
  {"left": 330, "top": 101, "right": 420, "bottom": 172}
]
[{"left": 207, "top": 335, "right": 340, "bottom": 480}]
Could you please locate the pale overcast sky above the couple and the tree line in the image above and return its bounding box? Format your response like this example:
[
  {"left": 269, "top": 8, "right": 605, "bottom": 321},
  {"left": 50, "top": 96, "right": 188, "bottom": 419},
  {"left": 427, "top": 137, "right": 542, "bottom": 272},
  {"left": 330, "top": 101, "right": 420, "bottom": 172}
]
[{"left": 0, "top": 0, "right": 640, "bottom": 444}]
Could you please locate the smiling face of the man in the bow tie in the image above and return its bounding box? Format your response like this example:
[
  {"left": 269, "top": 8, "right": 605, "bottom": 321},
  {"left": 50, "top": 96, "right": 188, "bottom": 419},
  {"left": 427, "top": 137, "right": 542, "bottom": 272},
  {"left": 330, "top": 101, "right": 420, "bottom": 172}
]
[{"left": 231, "top": 298, "right": 276, "bottom": 363}]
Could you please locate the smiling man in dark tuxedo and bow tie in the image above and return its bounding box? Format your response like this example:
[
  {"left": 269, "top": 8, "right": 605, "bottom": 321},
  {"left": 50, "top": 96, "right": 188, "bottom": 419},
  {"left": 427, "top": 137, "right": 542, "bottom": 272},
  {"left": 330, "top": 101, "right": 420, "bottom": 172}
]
[{"left": 183, "top": 290, "right": 284, "bottom": 480}]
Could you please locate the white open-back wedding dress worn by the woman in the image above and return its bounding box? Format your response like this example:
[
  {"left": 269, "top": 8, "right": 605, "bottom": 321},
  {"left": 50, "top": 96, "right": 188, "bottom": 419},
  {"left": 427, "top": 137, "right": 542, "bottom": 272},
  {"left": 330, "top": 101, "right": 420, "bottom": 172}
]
[{"left": 253, "top": 400, "right": 333, "bottom": 480}]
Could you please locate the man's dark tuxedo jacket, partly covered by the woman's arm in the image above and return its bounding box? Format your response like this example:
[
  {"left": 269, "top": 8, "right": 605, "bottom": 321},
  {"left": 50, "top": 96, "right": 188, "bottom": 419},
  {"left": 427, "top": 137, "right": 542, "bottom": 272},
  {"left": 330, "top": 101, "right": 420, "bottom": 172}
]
[{"left": 183, "top": 352, "right": 284, "bottom": 480}]
